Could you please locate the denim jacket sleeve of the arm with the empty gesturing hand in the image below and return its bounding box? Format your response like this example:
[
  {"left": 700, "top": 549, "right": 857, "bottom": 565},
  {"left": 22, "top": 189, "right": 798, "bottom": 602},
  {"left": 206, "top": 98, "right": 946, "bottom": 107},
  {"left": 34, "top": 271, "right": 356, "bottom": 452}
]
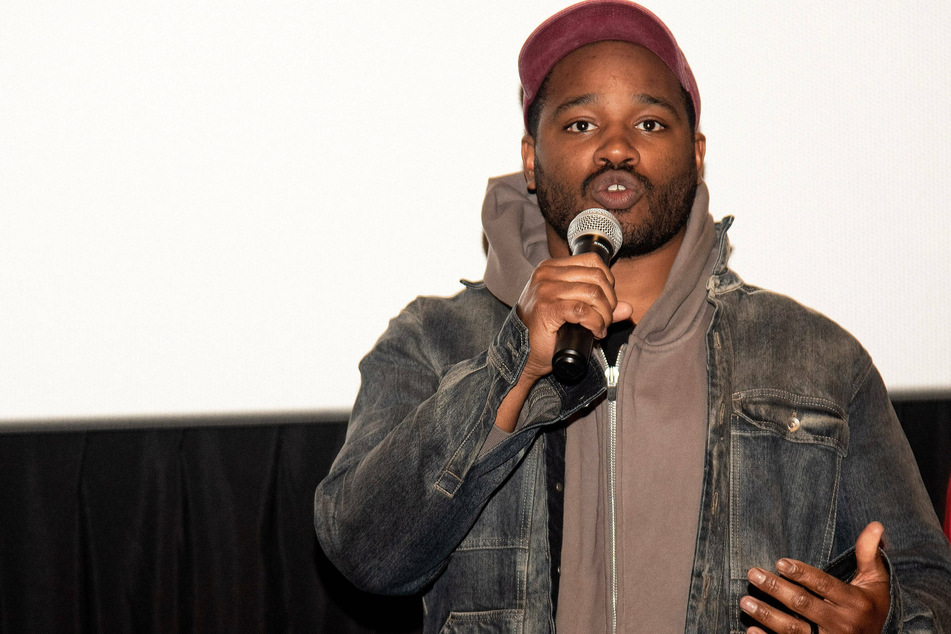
[{"left": 836, "top": 362, "right": 951, "bottom": 632}]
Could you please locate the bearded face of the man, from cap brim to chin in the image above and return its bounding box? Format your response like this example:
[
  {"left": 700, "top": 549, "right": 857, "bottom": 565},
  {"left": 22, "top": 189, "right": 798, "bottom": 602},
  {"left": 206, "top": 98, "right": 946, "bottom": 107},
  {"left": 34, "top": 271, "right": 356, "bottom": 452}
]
[{"left": 522, "top": 42, "right": 705, "bottom": 257}]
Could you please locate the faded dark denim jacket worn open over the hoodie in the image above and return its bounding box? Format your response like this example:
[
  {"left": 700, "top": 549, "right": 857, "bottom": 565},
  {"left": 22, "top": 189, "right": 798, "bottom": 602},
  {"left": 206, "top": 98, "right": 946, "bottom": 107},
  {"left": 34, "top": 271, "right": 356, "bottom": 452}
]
[{"left": 315, "top": 219, "right": 951, "bottom": 634}]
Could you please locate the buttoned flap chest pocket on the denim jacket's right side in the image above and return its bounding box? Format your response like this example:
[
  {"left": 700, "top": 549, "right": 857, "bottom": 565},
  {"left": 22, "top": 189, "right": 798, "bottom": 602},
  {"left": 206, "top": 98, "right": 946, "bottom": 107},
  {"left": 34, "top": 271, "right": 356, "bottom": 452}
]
[{"left": 730, "top": 389, "right": 849, "bottom": 579}]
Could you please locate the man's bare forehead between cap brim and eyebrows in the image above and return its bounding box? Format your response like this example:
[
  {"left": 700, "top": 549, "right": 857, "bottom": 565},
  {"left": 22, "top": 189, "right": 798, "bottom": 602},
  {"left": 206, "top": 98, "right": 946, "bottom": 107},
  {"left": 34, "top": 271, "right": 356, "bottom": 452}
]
[{"left": 546, "top": 41, "right": 682, "bottom": 103}]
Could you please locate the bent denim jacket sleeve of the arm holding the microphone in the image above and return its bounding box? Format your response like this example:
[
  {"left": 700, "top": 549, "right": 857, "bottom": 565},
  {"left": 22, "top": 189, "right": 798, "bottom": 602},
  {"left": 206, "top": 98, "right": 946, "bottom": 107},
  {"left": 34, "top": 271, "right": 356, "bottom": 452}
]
[{"left": 314, "top": 300, "right": 600, "bottom": 594}]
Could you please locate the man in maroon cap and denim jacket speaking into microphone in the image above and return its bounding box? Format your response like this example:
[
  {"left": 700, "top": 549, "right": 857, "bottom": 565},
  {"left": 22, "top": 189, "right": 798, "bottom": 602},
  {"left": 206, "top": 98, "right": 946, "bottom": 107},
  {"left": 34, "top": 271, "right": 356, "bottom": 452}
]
[{"left": 315, "top": 0, "right": 951, "bottom": 632}]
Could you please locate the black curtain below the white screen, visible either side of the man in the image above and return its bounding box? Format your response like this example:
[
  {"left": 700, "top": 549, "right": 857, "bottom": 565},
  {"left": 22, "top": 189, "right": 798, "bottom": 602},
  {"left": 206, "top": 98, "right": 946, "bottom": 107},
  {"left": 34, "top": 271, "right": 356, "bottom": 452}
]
[{"left": 0, "top": 400, "right": 951, "bottom": 633}]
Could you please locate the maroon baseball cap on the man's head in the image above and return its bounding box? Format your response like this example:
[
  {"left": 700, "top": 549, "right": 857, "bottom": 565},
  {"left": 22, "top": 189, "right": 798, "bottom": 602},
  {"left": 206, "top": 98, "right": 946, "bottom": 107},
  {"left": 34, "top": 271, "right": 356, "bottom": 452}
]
[{"left": 518, "top": 0, "right": 700, "bottom": 128}]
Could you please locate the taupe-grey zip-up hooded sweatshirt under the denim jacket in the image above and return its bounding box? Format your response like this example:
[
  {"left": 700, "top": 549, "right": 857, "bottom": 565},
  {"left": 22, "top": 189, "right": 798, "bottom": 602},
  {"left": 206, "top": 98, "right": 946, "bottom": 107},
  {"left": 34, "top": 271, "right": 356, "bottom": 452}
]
[{"left": 482, "top": 174, "right": 716, "bottom": 633}]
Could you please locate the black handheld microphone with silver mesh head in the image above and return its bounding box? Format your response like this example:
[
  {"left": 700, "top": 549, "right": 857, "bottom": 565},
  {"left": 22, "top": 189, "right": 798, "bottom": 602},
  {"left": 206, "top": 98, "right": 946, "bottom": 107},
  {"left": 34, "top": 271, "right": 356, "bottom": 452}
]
[{"left": 551, "top": 207, "right": 623, "bottom": 384}]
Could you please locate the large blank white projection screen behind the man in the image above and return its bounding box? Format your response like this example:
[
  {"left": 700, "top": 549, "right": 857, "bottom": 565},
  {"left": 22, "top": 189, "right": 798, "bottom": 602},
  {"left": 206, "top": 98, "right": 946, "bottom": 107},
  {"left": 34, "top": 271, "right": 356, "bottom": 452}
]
[{"left": 0, "top": 0, "right": 951, "bottom": 429}]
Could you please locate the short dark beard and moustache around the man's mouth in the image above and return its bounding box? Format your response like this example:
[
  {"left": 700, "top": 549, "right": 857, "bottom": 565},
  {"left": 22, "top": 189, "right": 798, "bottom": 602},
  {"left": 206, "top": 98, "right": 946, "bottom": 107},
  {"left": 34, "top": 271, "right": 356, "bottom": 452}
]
[{"left": 535, "top": 157, "right": 697, "bottom": 258}]
